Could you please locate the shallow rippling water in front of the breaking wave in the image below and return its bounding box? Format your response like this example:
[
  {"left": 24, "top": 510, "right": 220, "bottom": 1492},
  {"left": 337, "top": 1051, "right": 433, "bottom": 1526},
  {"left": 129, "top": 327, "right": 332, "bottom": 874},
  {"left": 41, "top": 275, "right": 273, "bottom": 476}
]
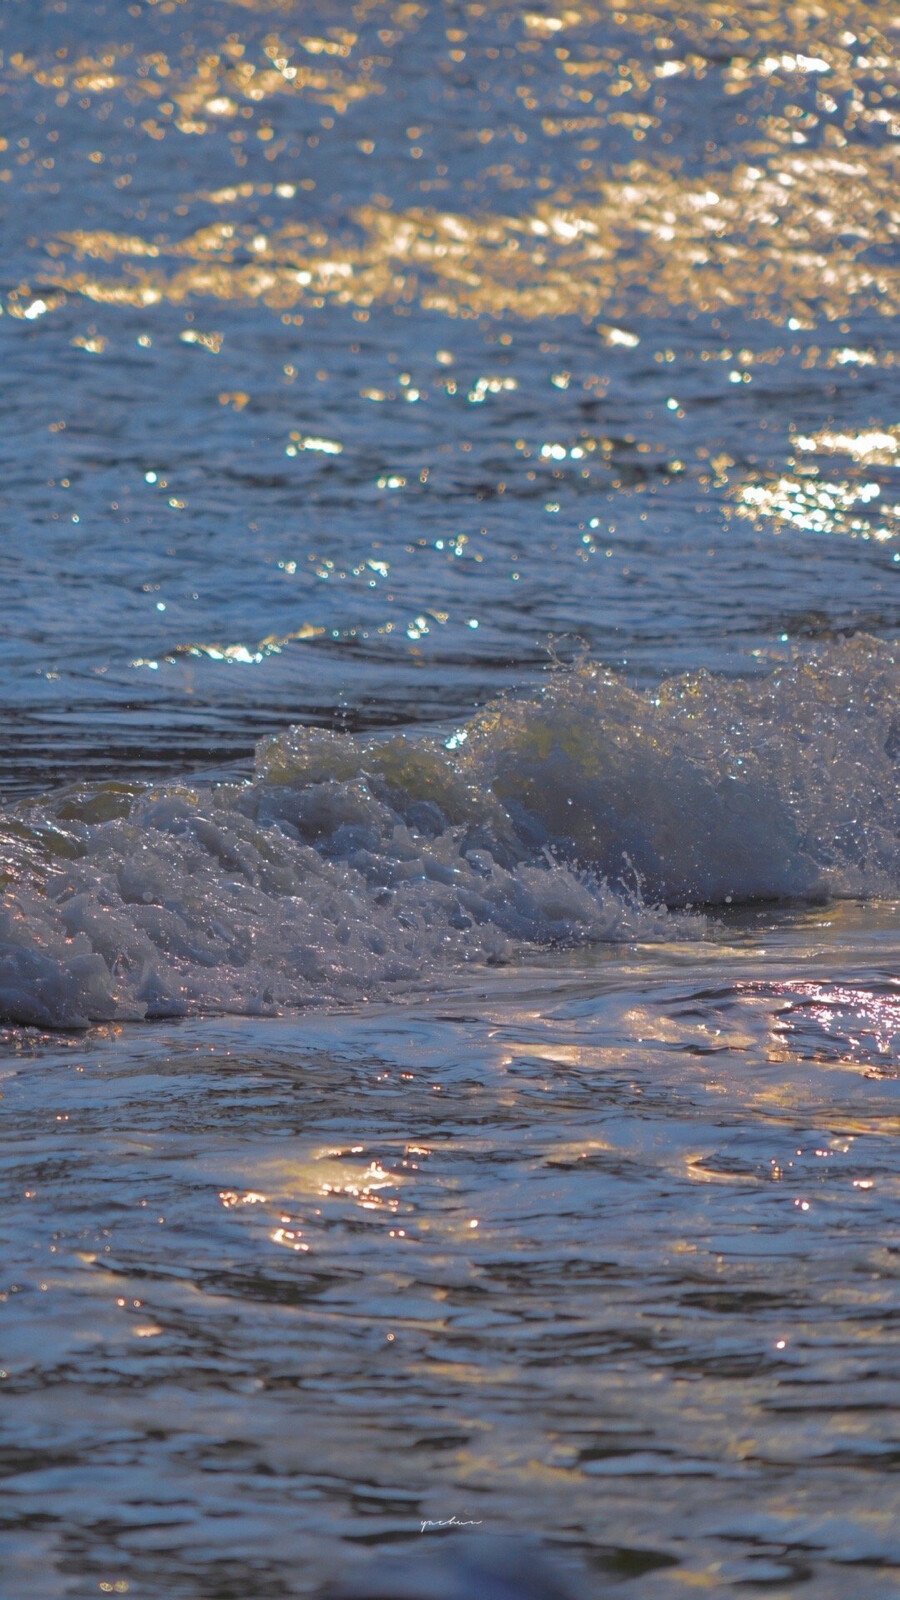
[{"left": 2, "top": 906, "right": 900, "bottom": 1597}]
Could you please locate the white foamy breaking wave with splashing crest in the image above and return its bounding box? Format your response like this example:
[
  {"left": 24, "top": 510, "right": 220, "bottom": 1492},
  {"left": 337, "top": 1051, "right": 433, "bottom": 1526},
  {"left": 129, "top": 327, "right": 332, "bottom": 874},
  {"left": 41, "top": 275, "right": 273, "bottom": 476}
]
[{"left": 0, "top": 638, "right": 900, "bottom": 1026}]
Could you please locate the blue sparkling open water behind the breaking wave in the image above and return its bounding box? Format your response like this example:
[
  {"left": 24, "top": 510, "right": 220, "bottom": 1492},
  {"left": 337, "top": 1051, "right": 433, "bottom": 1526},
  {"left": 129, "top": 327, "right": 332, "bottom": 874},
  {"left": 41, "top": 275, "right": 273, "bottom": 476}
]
[{"left": 0, "top": 0, "right": 898, "bottom": 794}]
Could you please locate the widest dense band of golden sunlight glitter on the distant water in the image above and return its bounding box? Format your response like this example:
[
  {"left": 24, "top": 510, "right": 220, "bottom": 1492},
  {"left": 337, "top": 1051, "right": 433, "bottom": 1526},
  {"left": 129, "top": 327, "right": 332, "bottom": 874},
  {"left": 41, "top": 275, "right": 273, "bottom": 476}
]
[{"left": 24, "top": 149, "right": 900, "bottom": 328}]
